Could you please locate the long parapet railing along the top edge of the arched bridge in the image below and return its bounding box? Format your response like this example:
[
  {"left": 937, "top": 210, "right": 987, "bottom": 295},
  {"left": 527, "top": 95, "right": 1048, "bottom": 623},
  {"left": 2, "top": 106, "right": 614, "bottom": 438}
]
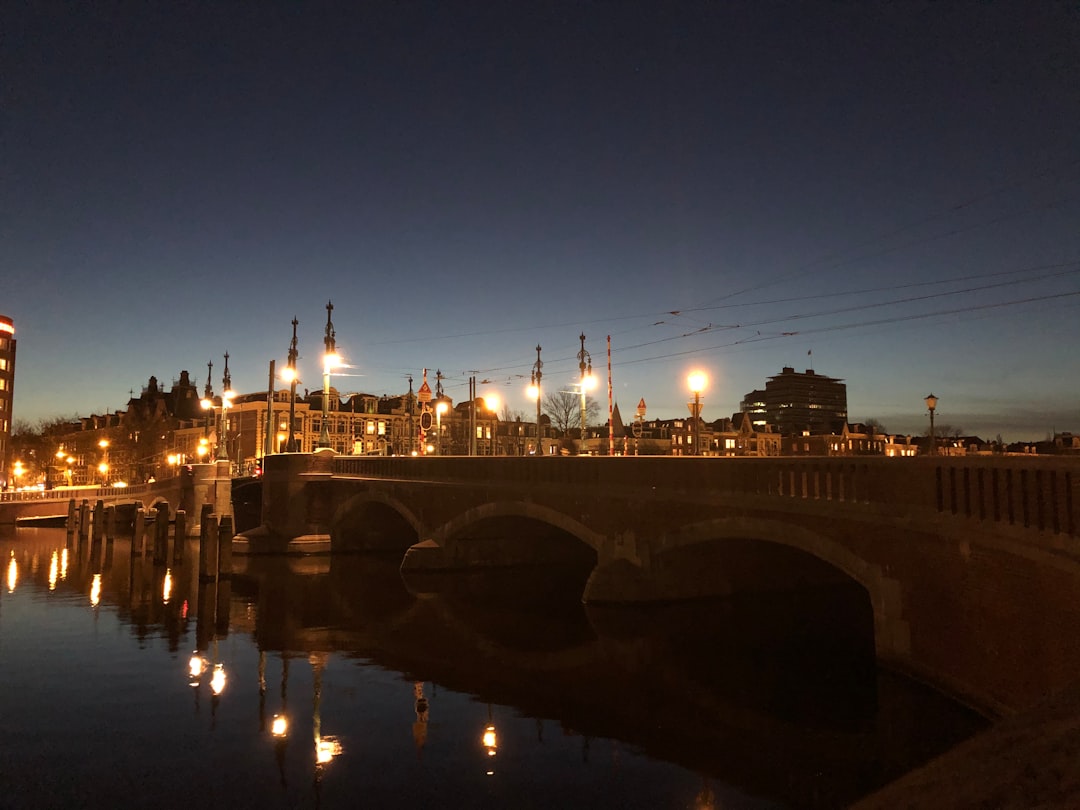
[{"left": 335, "top": 456, "right": 1080, "bottom": 536}]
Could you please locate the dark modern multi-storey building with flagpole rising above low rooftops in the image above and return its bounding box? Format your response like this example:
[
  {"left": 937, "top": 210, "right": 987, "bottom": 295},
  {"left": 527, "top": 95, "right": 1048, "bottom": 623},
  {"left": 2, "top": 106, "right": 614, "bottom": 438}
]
[{"left": 741, "top": 366, "right": 848, "bottom": 435}]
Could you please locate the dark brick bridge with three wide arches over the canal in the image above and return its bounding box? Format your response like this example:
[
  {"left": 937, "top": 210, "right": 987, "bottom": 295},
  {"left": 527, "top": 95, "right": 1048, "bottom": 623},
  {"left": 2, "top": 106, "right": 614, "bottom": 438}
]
[{"left": 241, "top": 450, "right": 1080, "bottom": 715}]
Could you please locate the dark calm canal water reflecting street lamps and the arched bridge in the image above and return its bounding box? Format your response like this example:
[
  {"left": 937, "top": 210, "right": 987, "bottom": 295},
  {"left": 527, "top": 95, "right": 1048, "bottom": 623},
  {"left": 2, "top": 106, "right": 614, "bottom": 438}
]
[{"left": 0, "top": 528, "right": 985, "bottom": 810}]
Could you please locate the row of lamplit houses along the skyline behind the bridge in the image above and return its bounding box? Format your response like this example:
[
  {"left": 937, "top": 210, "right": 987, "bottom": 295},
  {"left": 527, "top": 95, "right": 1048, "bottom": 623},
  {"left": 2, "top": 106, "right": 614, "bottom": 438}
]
[{"left": 8, "top": 369, "right": 1080, "bottom": 487}]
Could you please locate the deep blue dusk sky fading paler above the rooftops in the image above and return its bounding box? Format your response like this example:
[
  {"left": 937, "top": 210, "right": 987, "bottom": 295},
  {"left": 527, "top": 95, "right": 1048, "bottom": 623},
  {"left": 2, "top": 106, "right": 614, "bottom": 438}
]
[{"left": 0, "top": 0, "right": 1080, "bottom": 441}]
